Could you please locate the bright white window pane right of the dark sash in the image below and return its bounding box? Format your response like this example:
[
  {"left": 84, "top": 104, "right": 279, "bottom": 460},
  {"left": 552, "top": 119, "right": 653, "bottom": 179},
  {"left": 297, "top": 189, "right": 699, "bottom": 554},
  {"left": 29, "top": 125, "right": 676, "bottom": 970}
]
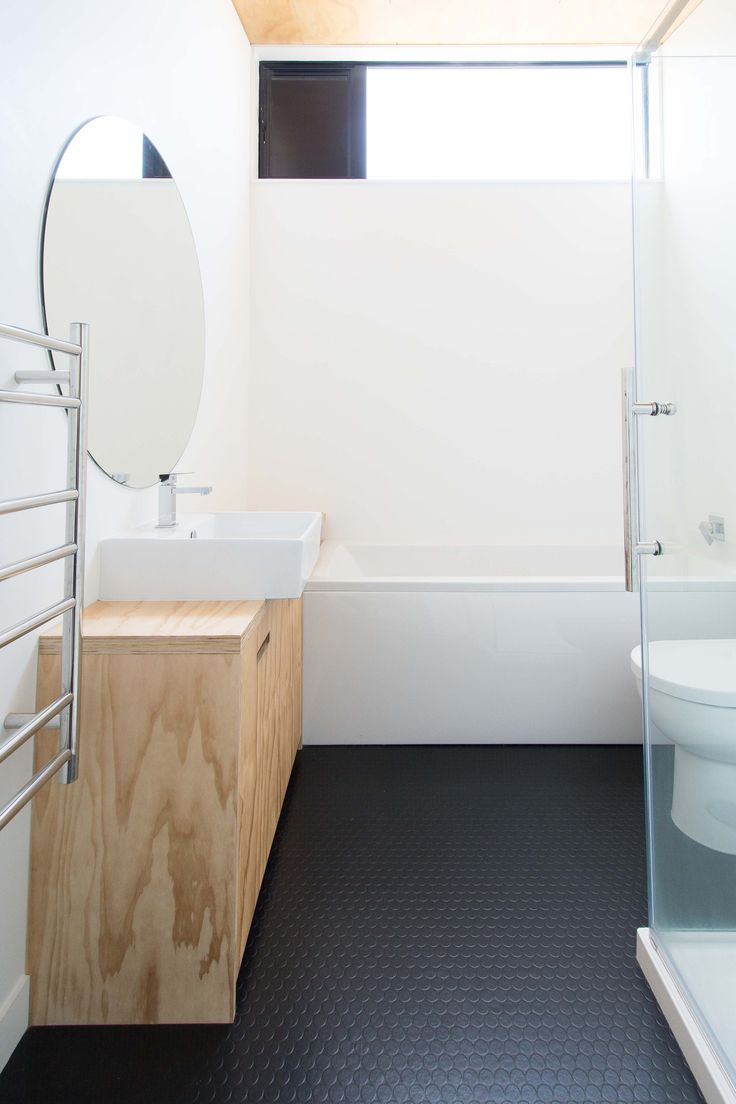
[{"left": 365, "top": 64, "right": 631, "bottom": 180}]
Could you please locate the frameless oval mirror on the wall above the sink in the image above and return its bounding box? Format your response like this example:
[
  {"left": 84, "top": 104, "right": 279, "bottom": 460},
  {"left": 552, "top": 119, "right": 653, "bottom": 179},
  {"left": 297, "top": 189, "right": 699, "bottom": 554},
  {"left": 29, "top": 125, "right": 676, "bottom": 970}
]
[{"left": 41, "top": 116, "right": 204, "bottom": 487}]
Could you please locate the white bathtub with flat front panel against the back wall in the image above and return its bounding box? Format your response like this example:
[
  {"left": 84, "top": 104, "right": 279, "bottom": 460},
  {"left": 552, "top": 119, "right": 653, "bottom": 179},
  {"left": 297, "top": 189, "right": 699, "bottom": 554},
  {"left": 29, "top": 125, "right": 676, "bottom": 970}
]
[{"left": 305, "top": 541, "right": 641, "bottom": 744}]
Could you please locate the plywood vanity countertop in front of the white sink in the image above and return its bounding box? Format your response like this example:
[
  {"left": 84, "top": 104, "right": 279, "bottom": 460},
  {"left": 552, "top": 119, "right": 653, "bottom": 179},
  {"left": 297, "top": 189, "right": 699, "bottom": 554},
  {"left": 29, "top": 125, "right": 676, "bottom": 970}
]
[{"left": 39, "top": 602, "right": 265, "bottom": 655}]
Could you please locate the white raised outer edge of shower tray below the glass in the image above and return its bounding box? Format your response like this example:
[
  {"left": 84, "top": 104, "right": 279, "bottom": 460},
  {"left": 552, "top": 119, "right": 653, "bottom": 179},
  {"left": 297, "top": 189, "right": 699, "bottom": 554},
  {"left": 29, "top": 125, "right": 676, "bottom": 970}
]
[{"left": 637, "top": 927, "right": 736, "bottom": 1104}]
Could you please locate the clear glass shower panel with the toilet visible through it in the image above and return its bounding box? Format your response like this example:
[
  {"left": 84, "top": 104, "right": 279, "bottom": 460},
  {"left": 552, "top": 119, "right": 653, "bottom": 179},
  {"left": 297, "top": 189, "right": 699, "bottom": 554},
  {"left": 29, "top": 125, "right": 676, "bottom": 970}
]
[{"left": 632, "top": 57, "right": 736, "bottom": 1081}]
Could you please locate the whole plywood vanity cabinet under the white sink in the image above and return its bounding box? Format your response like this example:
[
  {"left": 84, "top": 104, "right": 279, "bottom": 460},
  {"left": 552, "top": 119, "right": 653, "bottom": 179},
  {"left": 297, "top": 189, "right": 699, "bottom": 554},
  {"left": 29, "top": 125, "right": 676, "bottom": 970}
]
[{"left": 29, "top": 599, "right": 301, "bottom": 1025}]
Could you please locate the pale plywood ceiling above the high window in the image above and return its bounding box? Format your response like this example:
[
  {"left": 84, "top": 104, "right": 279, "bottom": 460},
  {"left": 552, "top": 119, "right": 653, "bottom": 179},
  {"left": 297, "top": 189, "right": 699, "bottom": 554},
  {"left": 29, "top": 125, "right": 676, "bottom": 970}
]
[{"left": 234, "top": 0, "right": 697, "bottom": 45}]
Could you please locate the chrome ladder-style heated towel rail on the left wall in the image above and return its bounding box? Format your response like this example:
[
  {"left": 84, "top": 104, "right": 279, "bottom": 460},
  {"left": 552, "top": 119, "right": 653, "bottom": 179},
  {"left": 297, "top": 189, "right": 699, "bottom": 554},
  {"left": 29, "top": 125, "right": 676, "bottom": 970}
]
[{"left": 0, "top": 322, "right": 89, "bottom": 829}]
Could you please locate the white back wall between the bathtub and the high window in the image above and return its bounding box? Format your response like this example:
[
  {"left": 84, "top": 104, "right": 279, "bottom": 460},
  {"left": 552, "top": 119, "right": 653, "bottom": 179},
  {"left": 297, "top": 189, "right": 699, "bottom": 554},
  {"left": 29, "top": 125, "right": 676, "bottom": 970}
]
[{"left": 248, "top": 181, "right": 633, "bottom": 544}]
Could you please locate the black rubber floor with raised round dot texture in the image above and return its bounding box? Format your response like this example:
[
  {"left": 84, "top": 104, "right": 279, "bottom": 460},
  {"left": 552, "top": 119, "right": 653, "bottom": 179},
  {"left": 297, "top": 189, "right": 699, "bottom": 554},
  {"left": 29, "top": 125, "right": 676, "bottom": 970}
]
[{"left": 0, "top": 747, "right": 701, "bottom": 1104}]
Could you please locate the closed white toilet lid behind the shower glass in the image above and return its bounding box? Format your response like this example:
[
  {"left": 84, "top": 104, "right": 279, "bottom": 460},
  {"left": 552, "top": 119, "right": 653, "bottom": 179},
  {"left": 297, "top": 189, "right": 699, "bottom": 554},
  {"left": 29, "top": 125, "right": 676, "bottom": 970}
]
[{"left": 631, "top": 640, "right": 736, "bottom": 707}]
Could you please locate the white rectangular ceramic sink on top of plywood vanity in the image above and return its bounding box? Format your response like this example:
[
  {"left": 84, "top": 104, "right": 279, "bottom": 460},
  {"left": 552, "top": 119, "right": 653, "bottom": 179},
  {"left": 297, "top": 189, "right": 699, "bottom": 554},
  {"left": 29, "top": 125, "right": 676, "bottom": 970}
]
[{"left": 99, "top": 511, "right": 322, "bottom": 602}]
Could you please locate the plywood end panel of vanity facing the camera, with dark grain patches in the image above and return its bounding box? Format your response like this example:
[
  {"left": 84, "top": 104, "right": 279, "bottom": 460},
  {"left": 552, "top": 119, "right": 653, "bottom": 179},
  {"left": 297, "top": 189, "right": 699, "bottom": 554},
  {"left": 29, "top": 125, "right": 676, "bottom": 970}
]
[{"left": 29, "top": 655, "right": 239, "bottom": 1023}]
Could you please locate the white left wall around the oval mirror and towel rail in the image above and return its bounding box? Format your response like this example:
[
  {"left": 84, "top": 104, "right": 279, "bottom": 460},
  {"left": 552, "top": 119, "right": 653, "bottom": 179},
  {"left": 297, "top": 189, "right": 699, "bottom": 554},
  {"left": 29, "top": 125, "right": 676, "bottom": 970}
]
[{"left": 0, "top": 0, "right": 249, "bottom": 1066}]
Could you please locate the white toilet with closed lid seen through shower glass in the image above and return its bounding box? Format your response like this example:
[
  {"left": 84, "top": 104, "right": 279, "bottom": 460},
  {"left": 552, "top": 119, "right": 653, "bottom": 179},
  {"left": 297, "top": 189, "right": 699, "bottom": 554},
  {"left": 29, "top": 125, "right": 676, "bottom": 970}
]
[{"left": 631, "top": 640, "right": 736, "bottom": 854}]
